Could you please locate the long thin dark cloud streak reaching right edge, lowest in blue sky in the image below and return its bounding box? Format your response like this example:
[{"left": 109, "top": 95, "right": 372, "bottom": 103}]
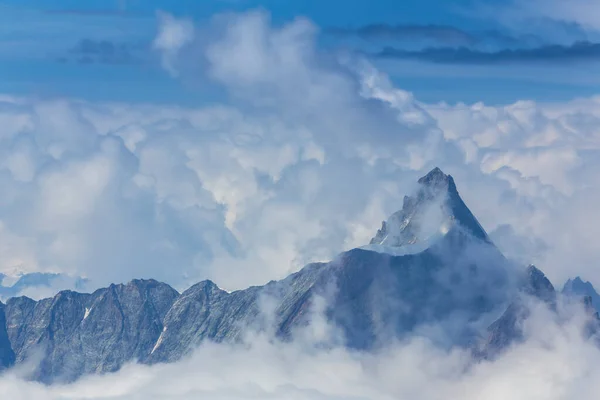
[{"left": 374, "top": 42, "right": 600, "bottom": 64}]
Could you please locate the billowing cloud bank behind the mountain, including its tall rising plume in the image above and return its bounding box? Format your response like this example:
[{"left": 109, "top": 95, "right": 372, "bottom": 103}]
[{"left": 0, "top": 7, "right": 600, "bottom": 300}]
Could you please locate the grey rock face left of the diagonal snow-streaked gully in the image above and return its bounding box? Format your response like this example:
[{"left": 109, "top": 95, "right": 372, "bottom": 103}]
[{"left": 4, "top": 280, "right": 179, "bottom": 382}]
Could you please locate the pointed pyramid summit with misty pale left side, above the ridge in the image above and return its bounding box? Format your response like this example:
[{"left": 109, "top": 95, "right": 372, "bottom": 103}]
[{"left": 370, "top": 167, "right": 489, "bottom": 248}]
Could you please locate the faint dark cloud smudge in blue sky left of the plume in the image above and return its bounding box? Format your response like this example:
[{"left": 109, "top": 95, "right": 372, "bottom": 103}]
[{"left": 57, "top": 39, "right": 144, "bottom": 65}]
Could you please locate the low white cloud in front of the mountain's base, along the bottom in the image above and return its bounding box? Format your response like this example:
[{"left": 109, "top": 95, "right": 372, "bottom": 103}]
[{"left": 0, "top": 292, "right": 600, "bottom": 400}]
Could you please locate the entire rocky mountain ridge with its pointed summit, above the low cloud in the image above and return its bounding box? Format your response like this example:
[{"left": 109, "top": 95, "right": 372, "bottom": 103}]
[{"left": 0, "top": 168, "right": 580, "bottom": 383}]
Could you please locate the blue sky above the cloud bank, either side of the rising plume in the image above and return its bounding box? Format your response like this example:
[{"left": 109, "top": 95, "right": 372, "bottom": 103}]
[{"left": 0, "top": 0, "right": 600, "bottom": 104}]
